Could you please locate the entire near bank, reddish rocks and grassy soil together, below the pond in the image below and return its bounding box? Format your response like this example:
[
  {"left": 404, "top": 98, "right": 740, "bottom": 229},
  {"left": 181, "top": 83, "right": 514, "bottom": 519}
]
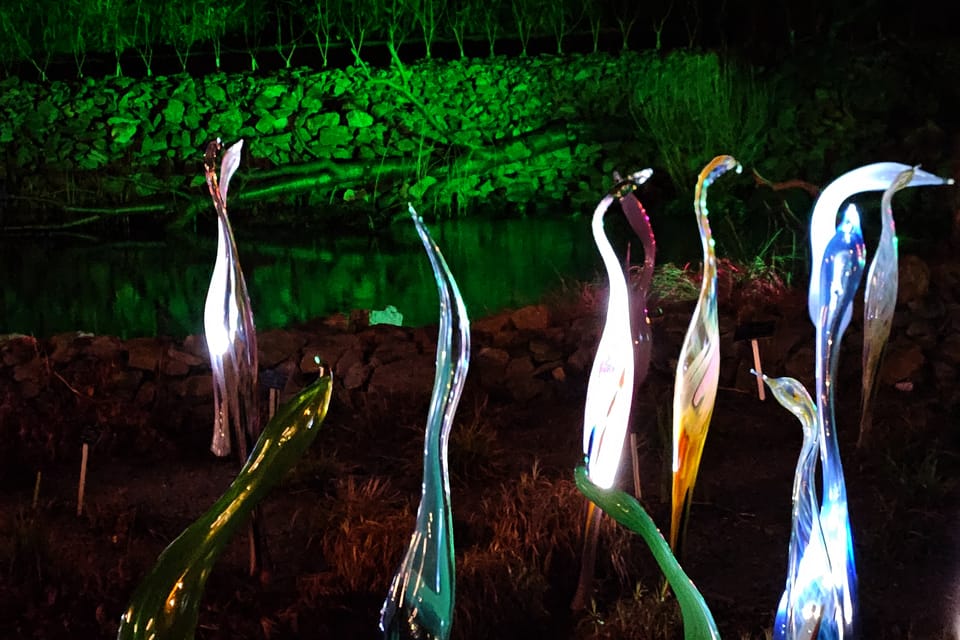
[{"left": 0, "top": 256, "right": 960, "bottom": 639}]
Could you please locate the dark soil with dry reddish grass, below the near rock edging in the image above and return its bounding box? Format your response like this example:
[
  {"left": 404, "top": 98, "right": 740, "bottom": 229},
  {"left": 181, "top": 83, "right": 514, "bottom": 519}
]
[{"left": 0, "top": 286, "right": 960, "bottom": 640}]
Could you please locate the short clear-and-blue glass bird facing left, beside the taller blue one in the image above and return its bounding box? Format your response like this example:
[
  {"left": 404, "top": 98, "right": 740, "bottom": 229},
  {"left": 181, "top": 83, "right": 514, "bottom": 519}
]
[{"left": 762, "top": 376, "right": 839, "bottom": 640}]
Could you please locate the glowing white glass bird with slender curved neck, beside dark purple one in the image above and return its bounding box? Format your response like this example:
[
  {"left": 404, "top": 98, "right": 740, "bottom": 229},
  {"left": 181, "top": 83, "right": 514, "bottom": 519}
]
[{"left": 583, "top": 169, "right": 653, "bottom": 489}]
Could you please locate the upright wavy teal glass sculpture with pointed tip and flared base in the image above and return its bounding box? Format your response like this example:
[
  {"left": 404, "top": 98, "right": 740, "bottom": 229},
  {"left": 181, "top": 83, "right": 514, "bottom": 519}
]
[{"left": 380, "top": 205, "right": 470, "bottom": 640}]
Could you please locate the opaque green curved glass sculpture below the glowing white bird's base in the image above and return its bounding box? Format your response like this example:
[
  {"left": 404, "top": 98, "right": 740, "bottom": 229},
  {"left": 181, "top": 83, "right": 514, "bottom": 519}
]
[{"left": 574, "top": 466, "right": 720, "bottom": 640}]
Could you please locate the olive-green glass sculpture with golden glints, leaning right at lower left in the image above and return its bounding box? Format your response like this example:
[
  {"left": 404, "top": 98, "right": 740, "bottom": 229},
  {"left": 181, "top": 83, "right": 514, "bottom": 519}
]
[{"left": 117, "top": 371, "right": 332, "bottom": 640}]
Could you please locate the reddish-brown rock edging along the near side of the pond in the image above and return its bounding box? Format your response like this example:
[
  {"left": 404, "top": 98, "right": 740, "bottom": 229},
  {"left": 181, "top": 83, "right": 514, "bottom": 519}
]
[{"left": 0, "top": 251, "right": 960, "bottom": 472}]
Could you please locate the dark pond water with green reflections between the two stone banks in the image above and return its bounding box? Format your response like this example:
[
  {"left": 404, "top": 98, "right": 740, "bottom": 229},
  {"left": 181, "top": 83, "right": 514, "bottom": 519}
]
[{"left": 0, "top": 216, "right": 695, "bottom": 338}]
